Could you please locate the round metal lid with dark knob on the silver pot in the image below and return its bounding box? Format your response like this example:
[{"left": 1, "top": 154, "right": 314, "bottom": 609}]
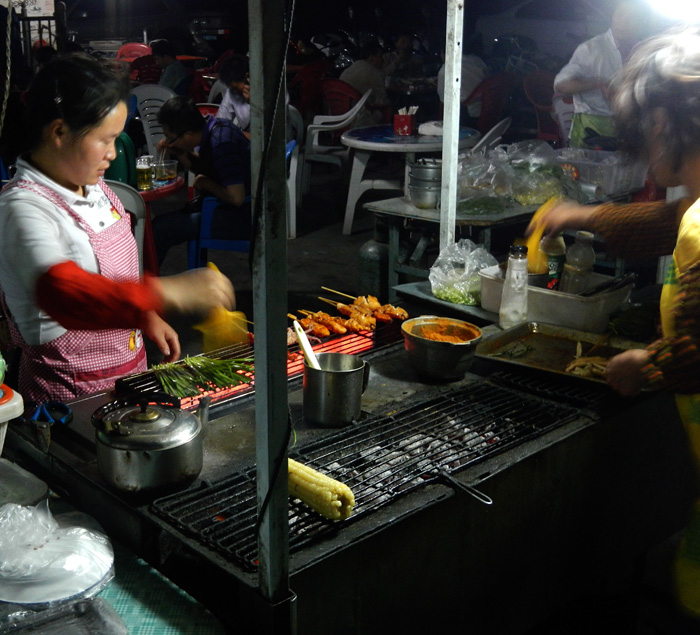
[{"left": 92, "top": 393, "right": 202, "bottom": 450}]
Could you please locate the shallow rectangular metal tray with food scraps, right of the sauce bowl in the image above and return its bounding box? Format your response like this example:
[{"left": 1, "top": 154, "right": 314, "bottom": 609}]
[{"left": 476, "top": 322, "right": 644, "bottom": 383}]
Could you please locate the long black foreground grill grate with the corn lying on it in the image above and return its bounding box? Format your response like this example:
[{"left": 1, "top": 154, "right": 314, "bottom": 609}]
[{"left": 152, "top": 381, "right": 581, "bottom": 571}]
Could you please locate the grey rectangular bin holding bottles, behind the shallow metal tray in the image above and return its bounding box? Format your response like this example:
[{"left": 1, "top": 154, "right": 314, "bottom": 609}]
[{"left": 479, "top": 265, "right": 634, "bottom": 333}]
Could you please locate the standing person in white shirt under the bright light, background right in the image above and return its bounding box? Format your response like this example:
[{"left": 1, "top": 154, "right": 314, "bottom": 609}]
[{"left": 554, "top": 0, "right": 647, "bottom": 148}]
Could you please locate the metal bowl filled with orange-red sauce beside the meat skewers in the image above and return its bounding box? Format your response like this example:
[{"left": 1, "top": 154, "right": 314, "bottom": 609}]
[{"left": 401, "top": 315, "right": 481, "bottom": 381}]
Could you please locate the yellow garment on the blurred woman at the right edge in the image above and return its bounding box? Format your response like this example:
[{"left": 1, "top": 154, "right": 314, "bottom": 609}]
[{"left": 660, "top": 201, "right": 700, "bottom": 617}]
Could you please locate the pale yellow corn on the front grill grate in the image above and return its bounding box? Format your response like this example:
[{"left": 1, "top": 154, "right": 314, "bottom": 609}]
[{"left": 289, "top": 459, "right": 355, "bottom": 520}]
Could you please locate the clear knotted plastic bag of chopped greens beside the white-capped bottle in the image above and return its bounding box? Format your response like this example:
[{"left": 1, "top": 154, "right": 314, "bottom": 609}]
[{"left": 428, "top": 238, "right": 498, "bottom": 306}]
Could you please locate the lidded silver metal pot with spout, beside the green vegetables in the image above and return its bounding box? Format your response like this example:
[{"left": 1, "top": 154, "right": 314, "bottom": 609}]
[{"left": 92, "top": 393, "right": 208, "bottom": 494}]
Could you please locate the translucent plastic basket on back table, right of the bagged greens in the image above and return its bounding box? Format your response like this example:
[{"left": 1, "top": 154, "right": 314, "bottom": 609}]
[{"left": 557, "top": 148, "right": 648, "bottom": 196}]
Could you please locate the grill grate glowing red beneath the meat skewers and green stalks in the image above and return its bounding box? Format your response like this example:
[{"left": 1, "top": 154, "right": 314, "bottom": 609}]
[{"left": 115, "top": 323, "right": 402, "bottom": 410}]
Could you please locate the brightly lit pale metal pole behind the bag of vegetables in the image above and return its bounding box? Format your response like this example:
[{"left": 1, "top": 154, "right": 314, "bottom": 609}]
[{"left": 440, "top": 0, "right": 464, "bottom": 251}]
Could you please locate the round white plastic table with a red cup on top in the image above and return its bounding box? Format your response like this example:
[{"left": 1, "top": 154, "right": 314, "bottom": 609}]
[{"left": 340, "top": 124, "right": 480, "bottom": 236}]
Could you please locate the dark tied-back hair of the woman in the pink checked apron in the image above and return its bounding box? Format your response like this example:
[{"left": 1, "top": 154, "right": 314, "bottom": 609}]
[{"left": 25, "top": 53, "right": 131, "bottom": 149}]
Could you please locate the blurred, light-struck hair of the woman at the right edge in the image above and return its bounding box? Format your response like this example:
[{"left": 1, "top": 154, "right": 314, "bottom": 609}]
[{"left": 613, "top": 27, "right": 700, "bottom": 170}]
